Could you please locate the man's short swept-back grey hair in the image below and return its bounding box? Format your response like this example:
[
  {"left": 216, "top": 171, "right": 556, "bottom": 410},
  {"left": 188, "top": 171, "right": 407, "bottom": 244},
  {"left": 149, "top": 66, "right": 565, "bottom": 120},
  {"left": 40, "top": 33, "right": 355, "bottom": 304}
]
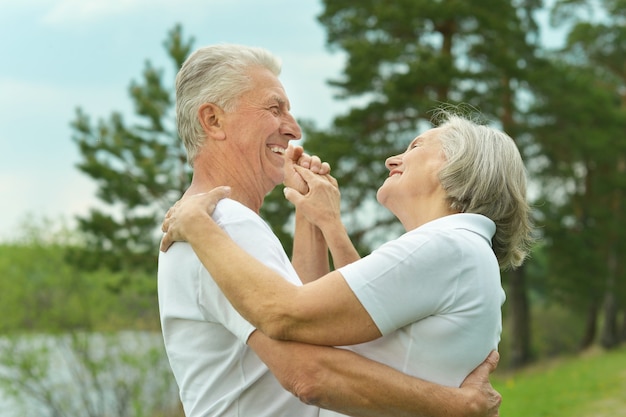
[{"left": 176, "top": 44, "right": 281, "bottom": 166}]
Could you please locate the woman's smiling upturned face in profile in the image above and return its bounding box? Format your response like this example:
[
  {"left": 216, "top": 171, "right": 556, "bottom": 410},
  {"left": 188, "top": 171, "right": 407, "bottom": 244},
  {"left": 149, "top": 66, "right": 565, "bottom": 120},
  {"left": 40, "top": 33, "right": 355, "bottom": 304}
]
[{"left": 377, "top": 128, "right": 448, "bottom": 227}]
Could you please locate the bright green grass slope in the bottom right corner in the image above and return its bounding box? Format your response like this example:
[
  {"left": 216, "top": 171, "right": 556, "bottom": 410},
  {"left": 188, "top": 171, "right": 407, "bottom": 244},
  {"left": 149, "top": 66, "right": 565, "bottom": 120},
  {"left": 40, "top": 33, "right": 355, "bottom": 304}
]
[{"left": 492, "top": 347, "right": 626, "bottom": 417}]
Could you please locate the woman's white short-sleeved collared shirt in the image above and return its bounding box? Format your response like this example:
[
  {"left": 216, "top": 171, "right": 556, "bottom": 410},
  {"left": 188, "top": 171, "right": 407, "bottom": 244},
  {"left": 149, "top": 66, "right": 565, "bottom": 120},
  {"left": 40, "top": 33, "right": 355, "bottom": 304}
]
[{"left": 320, "top": 214, "right": 505, "bottom": 417}]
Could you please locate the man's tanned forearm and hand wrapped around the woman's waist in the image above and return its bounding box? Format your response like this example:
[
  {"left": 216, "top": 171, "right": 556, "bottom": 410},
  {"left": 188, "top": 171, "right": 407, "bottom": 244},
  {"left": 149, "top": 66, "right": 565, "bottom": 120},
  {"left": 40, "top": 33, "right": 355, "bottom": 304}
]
[{"left": 248, "top": 331, "right": 502, "bottom": 417}]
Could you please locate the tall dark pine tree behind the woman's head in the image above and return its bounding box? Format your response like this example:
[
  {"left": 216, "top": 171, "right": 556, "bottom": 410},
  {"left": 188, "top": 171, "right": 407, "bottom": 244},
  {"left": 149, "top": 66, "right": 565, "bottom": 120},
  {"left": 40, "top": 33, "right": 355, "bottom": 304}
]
[{"left": 305, "top": 0, "right": 540, "bottom": 362}]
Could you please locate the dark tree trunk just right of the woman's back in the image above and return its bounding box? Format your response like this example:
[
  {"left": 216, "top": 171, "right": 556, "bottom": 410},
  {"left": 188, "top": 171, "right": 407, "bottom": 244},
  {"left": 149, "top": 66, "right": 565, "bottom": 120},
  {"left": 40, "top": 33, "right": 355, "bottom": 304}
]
[{"left": 507, "top": 266, "right": 531, "bottom": 369}]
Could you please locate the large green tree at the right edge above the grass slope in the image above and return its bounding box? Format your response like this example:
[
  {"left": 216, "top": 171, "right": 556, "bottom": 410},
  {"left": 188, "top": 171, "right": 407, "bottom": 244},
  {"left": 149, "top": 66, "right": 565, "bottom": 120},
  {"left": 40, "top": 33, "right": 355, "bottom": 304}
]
[{"left": 536, "top": 0, "right": 626, "bottom": 348}]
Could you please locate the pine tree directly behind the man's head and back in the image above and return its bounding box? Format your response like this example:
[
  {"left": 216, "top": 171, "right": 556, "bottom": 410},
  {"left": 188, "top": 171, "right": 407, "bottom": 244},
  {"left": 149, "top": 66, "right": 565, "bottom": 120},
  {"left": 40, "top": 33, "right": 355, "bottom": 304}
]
[{"left": 69, "top": 25, "right": 193, "bottom": 280}]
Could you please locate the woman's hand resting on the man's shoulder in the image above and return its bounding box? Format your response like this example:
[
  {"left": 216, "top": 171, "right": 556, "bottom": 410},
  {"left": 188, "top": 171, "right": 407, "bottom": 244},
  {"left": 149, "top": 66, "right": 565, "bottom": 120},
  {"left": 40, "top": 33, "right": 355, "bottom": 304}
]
[{"left": 160, "top": 186, "right": 230, "bottom": 252}]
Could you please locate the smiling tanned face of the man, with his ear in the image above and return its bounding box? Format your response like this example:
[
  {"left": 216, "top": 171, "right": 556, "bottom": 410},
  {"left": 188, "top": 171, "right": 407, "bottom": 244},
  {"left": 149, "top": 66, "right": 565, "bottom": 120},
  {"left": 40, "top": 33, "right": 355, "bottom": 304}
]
[{"left": 223, "top": 68, "right": 302, "bottom": 193}]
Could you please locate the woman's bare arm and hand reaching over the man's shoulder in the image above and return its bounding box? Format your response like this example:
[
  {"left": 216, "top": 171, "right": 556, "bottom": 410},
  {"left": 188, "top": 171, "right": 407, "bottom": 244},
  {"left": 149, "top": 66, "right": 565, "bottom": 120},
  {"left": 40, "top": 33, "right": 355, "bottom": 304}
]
[{"left": 161, "top": 187, "right": 381, "bottom": 346}]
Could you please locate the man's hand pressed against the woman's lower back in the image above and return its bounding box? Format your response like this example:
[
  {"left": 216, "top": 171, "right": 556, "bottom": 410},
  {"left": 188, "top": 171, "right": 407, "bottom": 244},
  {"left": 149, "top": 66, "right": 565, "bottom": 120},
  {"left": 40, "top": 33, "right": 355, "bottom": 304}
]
[{"left": 461, "top": 350, "right": 502, "bottom": 417}]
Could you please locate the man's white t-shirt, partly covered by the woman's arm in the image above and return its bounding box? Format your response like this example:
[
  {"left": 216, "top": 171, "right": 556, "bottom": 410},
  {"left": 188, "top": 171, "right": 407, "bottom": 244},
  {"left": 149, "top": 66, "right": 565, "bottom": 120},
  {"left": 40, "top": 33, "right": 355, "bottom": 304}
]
[{"left": 158, "top": 200, "right": 318, "bottom": 417}]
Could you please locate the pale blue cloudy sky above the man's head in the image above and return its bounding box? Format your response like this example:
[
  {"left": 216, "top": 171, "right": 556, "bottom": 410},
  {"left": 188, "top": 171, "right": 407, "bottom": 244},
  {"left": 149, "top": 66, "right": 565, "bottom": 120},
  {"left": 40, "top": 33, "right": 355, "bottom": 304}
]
[{"left": 0, "top": 0, "right": 345, "bottom": 241}]
